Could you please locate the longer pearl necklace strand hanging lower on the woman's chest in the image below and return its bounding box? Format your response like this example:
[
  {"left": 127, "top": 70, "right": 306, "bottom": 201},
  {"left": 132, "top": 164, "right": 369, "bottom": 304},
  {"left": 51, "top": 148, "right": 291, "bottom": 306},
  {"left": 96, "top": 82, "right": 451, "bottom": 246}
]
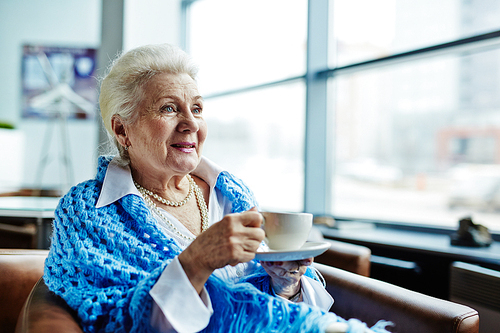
[{"left": 134, "top": 175, "right": 208, "bottom": 242}]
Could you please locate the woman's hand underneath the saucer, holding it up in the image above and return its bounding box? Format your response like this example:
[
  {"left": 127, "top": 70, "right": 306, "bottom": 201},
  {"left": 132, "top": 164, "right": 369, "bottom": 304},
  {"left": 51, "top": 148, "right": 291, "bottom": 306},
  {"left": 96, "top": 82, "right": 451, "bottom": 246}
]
[{"left": 261, "top": 258, "right": 313, "bottom": 301}]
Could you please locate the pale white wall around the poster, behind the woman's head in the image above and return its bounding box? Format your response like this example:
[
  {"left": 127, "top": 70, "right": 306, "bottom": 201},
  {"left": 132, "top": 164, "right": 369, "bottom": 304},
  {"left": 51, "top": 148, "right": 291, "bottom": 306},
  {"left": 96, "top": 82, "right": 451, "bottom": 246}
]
[{"left": 0, "top": 0, "right": 180, "bottom": 191}]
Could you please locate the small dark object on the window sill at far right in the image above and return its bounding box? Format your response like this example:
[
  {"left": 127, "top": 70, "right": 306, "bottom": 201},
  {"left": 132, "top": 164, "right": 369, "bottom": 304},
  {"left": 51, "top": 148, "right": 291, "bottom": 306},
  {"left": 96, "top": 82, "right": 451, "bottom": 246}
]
[{"left": 450, "top": 217, "right": 493, "bottom": 247}]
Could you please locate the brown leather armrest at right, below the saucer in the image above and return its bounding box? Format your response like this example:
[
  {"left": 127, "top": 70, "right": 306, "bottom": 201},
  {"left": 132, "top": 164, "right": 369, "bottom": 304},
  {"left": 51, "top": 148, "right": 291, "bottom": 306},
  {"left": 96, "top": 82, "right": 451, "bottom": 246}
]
[{"left": 314, "top": 263, "right": 479, "bottom": 333}]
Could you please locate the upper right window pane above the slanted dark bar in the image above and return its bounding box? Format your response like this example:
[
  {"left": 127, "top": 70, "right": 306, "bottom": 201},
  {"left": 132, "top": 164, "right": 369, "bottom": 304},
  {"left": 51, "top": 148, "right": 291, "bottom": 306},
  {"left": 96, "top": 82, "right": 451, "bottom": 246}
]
[{"left": 330, "top": 0, "right": 500, "bottom": 66}]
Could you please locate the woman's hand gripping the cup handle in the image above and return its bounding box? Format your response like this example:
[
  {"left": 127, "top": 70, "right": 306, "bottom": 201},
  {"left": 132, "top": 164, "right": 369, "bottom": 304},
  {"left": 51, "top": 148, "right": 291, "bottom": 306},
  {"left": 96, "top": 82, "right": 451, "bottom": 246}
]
[{"left": 179, "top": 210, "right": 265, "bottom": 293}]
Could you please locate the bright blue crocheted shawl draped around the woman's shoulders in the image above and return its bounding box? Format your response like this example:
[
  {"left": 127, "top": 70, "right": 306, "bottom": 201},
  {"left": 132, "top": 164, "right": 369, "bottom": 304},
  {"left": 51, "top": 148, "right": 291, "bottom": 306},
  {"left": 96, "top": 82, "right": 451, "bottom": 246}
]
[{"left": 44, "top": 156, "right": 392, "bottom": 333}]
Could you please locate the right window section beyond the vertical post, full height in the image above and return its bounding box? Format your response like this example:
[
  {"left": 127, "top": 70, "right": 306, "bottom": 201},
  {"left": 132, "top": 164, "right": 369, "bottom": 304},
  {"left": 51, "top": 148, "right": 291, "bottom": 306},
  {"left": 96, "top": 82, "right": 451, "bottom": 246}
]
[{"left": 329, "top": 0, "right": 500, "bottom": 231}]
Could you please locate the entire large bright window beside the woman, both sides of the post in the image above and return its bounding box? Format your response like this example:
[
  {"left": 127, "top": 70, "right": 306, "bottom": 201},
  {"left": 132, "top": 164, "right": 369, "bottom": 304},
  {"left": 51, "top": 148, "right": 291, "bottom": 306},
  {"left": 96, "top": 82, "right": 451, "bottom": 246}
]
[{"left": 187, "top": 0, "right": 500, "bottom": 231}]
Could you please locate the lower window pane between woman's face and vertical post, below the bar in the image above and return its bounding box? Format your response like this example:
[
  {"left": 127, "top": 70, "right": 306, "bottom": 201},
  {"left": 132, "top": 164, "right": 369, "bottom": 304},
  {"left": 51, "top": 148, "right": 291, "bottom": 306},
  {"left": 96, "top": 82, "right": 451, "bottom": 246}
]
[{"left": 203, "top": 82, "right": 305, "bottom": 211}]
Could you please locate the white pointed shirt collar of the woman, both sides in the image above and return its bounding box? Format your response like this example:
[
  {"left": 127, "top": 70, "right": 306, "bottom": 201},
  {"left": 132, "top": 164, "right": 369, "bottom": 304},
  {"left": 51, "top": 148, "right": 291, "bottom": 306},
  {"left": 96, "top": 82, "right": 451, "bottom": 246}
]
[{"left": 96, "top": 156, "right": 223, "bottom": 208}]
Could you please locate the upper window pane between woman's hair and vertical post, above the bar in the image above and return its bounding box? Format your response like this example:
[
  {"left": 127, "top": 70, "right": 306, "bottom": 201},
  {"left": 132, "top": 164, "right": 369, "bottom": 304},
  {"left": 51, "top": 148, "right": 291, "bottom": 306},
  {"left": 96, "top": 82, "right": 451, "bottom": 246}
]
[{"left": 189, "top": 0, "right": 307, "bottom": 95}]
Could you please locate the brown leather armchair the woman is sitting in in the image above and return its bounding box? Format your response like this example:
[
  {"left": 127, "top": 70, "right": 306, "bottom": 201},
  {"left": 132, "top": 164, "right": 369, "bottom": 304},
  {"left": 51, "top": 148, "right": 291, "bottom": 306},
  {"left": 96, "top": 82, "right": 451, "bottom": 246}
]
[{"left": 0, "top": 250, "right": 479, "bottom": 333}]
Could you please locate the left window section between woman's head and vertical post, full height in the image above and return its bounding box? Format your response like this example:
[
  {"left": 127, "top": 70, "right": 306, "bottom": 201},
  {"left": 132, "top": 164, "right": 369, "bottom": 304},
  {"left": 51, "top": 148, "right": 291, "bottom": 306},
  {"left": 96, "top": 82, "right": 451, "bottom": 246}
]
[{"left": 188, "top": 0, "right": 307, "bottom": 211}]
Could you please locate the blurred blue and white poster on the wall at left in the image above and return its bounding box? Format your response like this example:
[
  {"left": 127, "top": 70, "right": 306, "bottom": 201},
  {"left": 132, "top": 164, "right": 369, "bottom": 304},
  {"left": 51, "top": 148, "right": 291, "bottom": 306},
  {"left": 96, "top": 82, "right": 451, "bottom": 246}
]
[{"left": 22, "top": 45, "right": 97, "bottom": 119}]
